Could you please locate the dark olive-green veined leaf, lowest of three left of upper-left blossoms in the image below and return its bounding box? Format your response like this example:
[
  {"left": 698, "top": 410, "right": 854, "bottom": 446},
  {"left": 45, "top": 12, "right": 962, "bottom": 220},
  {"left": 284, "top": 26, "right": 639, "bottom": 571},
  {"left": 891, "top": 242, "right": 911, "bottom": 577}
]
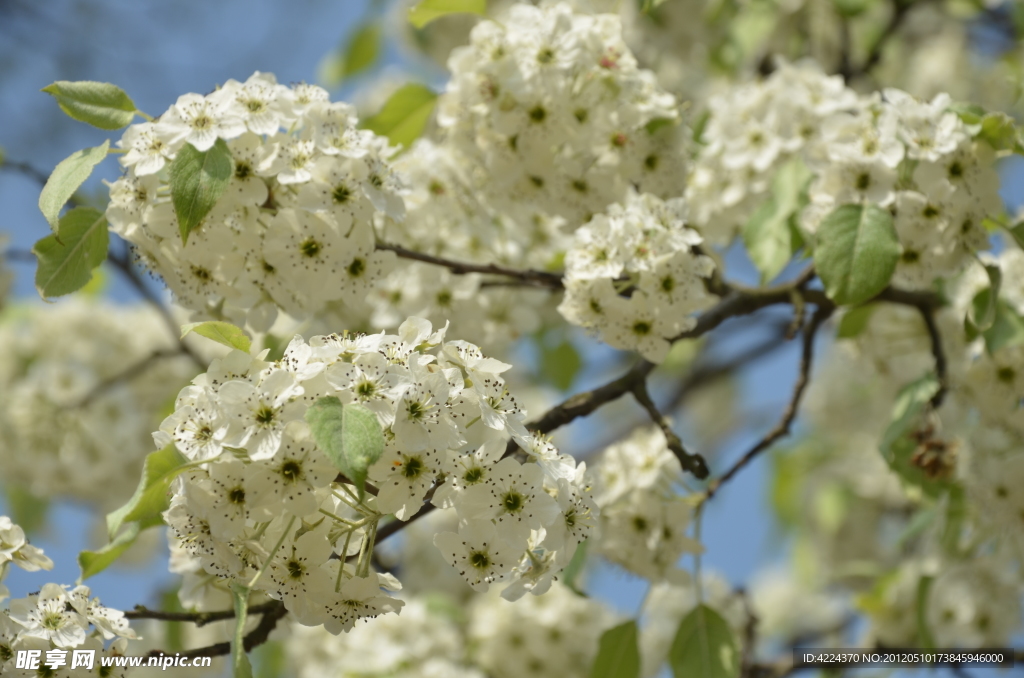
[{"left": 32, "top": 207, "right": 110, "bottom": 299}]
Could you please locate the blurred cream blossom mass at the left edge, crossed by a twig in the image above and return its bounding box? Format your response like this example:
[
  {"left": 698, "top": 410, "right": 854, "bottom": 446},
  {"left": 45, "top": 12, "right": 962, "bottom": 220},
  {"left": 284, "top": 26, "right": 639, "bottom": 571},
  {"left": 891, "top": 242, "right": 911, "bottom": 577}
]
[{"left": 0, "top": 298, "right": 196, "bottom": 510}]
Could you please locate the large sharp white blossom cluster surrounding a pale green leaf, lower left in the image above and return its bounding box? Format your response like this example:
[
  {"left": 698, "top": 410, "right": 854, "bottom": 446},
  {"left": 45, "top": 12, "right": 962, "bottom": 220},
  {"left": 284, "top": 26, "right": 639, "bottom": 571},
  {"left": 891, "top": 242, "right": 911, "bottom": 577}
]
[{"left": 154, "top": 319, "right": 596, "bottom": 633}]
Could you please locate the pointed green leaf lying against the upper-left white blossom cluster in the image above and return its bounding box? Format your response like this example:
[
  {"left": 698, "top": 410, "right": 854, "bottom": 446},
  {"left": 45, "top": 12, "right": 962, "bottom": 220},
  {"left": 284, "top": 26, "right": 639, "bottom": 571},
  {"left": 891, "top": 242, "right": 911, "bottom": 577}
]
[{"left": 170, "top": 139, "right": 234, "bottom": 243}]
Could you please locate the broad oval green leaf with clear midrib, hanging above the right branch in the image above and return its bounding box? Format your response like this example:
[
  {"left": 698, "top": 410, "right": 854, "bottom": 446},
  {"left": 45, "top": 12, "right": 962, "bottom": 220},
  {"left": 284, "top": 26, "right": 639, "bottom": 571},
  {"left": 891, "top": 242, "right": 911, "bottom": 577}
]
[{"left": 814, "top": 205, "right": 901, "bottom": 305}]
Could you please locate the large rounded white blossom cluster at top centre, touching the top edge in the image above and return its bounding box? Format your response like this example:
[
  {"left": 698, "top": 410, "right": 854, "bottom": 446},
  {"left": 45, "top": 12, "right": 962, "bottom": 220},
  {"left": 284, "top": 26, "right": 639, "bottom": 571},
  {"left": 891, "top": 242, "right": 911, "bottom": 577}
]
[{"left": 437, "top": 3, "right": 686, "bottom": 228}]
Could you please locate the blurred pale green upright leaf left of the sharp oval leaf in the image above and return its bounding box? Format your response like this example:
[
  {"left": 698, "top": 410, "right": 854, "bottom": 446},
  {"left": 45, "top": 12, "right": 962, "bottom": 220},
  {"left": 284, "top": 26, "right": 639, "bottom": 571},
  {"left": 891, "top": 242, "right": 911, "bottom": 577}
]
[{"left": 742, "top": 160, "right": 811, "bottom": 284}]
